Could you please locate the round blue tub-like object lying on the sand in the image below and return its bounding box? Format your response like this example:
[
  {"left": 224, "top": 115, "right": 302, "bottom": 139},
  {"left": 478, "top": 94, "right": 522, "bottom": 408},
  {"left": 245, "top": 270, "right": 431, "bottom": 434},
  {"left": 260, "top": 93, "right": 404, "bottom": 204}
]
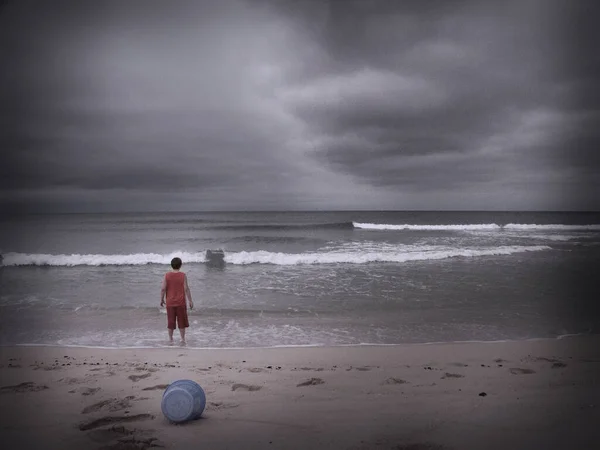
[{"left": 160, "top": 380, "right": 206, "bottom": 423}]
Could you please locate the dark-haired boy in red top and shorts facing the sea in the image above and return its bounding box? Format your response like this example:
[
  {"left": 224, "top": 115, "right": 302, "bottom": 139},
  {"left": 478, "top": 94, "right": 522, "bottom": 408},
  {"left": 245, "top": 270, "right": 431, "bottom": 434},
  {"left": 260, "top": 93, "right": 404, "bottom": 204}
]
[{"left": 160, "top": 258, "right": 194, "bottom": 344}]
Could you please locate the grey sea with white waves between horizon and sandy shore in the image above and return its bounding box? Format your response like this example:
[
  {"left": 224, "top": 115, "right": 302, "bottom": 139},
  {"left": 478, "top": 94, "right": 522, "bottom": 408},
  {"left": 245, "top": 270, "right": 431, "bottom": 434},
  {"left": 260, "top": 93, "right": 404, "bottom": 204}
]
[{"left": 0, "top": 211, "right": 600, "bottom": 348}]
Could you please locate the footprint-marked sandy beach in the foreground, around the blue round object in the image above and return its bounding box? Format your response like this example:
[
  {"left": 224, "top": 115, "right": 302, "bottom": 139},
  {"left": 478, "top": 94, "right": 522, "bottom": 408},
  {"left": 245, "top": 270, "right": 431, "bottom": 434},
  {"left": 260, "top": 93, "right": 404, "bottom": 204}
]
[{"left": 0, "top": 336, "right": 600, "bottom": 450}]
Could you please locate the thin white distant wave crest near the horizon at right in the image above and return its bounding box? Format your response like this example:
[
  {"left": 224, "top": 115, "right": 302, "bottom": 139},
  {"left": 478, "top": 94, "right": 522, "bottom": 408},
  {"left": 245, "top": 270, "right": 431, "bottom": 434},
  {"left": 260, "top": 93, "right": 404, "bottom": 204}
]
[{"left": 352, "top": 222, "right": 600, "bottom": 231}]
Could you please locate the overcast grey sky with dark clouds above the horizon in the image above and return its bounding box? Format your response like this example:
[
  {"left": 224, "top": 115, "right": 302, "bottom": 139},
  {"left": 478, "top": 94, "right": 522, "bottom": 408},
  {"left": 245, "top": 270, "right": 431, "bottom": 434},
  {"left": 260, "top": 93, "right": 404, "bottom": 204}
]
[{"left": 0, "top": 0, "right": 600, "bottom": 212}]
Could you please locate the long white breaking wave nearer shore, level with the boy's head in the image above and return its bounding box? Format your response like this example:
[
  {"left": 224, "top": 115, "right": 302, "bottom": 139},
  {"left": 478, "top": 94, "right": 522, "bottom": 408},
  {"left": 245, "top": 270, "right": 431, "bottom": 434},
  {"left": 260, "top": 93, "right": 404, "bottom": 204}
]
[{"left": 4, "top": 245, "right": 551, "bottom": 266}]
